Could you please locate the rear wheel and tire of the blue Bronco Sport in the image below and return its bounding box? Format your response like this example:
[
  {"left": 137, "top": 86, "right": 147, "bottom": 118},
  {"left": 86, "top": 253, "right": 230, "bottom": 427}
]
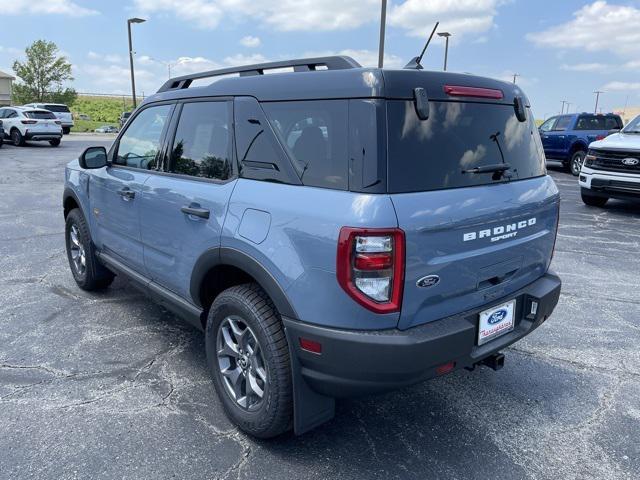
[{"left": 205, "top": 283, "right": 293, "bottom": 438}]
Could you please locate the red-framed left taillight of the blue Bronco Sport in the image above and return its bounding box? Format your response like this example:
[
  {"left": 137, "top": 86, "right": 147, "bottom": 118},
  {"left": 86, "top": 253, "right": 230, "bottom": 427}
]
[{"left": 336, "top": 227, "right": 404, "bottom": 313}]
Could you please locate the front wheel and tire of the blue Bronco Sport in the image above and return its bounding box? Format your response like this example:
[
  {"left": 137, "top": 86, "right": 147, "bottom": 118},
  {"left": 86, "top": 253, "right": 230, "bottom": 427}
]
[{"left": 64, "top": 208, "right": 115, "bottom": 291}]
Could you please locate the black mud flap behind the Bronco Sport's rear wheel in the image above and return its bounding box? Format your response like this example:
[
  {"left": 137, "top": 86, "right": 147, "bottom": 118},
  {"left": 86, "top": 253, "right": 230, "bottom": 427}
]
[{"left": 285, "top": 328, "right": 336, "bottom": 435}]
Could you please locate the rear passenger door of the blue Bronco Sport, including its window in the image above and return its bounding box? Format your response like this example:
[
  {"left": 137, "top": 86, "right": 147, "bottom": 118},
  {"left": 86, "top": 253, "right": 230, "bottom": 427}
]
[{"left": 140, "top": 100, "right": 235, "bottom": 299}]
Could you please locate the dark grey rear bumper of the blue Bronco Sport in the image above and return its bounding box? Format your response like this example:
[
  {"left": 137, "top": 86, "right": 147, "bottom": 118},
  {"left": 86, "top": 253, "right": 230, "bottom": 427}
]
[{"left": 283, "top": 273, "right": 561, "bottom": 397}]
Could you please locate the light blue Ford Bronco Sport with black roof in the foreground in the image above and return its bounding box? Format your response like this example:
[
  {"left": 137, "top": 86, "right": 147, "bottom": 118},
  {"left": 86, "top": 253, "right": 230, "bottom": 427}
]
[{"left": 63, "top": 57, "right": 560, "bottom": 437}]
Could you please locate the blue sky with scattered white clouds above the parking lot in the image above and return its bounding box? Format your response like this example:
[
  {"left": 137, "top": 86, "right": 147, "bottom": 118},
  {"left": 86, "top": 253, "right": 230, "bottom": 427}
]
[{"left": 0, "top": 0, "right": 640, "bottom": 118}]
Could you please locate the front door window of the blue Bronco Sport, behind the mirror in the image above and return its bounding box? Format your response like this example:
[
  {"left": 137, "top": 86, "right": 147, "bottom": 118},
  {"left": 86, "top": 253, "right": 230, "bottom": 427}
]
[{"left": 113, "top": 105, "right": 173, "bottom": 170}]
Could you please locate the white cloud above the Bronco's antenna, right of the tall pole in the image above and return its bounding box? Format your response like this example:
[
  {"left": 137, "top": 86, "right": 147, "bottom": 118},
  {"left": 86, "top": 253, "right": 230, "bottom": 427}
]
[{"left": 389, "top": 0, "right": 502, "bottom": 39}]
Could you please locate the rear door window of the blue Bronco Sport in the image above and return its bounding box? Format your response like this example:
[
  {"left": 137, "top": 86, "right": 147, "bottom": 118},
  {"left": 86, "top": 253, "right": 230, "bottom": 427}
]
[{"left": 169, "top": 102, "right": 232, "bottom": 180}]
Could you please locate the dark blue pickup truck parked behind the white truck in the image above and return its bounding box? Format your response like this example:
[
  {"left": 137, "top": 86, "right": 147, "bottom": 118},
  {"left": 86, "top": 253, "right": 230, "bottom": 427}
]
[{"left": 540, "top": 113, "right": 622, "bottom": 175}]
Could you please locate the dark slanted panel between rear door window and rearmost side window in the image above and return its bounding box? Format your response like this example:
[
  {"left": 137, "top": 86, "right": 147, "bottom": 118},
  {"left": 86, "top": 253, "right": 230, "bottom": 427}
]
[{"left": 234, "top": 97, "right": 301, "bottom": 184}]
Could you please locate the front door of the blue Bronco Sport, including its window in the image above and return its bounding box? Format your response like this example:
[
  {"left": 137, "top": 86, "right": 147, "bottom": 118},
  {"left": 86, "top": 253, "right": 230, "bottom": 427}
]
[{"left": 89, "top": 105, "right": 173, "bottom": 274}]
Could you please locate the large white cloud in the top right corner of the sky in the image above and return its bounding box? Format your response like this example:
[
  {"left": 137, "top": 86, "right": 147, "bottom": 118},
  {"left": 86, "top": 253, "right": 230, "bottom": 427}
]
[{"left": 527, "top": 0, "right": 640, "bottom": 55}]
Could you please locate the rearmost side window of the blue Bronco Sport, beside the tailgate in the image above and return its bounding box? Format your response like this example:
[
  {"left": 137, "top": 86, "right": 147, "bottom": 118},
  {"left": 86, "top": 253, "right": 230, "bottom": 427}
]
[{"left": 263, "top": 100, "right": 349, "bottom": 190}]
